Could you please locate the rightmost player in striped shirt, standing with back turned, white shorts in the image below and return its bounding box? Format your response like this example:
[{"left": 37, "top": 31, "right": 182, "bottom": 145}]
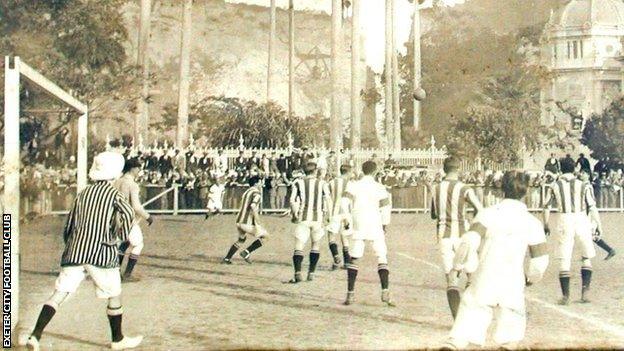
[{"left": 544, "top": 160, "right": 602, "bottom": 305}]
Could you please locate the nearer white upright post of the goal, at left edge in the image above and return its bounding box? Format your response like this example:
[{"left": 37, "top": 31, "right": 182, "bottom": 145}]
[{"left": 3, "top": 56, "right": 20, "bottom": 331}]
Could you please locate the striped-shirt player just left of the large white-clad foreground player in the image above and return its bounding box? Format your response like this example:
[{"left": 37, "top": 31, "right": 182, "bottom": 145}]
[{"left": 431, "top": 157, "right": 482, "bottom": 318}]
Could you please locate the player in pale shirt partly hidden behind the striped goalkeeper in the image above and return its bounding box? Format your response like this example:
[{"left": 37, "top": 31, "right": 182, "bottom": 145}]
[{"left": 114, "top": 158, "right": 154, "bottom": 282}]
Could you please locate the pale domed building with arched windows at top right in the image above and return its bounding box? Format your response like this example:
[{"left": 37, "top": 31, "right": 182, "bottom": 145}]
[{"left": 542, "top": 0, "right": 624, "bottom": 125}]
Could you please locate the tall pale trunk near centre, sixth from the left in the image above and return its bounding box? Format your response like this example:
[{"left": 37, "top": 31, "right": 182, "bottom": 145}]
[{"left": 351, "top": 0, "right": 362, "bottom": 150}]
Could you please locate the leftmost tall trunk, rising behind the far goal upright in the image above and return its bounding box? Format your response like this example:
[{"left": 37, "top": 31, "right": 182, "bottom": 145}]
[{"left": 134, "top": 0, "right": 152, "bottom": 142}]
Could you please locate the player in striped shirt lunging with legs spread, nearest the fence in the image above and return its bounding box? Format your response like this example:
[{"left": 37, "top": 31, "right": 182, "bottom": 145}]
[{"left": 221, "top": 176, "right": 268, "bottom": 264}]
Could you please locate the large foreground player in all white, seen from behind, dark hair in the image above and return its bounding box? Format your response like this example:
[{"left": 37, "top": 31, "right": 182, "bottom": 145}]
[{"left": 445, "top": 171, "right": 548, "bottom": 349}]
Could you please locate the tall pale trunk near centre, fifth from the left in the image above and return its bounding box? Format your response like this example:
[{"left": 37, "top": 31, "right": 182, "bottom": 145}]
[{"left": 329, "top": 0, "right": 342, "bottom": 150}]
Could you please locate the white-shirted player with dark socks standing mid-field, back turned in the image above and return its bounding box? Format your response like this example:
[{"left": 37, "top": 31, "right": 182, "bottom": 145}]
[{"left": 341, "top": 161, "right": 394, "bottom": 306}]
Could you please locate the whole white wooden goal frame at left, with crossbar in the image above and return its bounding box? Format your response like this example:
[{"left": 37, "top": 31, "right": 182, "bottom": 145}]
[{"left": 3, "top": 56, "right": 89, "bottom": 331}]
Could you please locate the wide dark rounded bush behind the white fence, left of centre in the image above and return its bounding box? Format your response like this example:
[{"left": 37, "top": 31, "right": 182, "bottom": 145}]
[{"left": 157, "top": 96, "right": 329, "bottom": 148}]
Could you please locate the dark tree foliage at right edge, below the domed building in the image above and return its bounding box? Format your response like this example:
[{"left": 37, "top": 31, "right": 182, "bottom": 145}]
[{"left": 581, "top": 98, "right": 624, "bottom": 163}]
